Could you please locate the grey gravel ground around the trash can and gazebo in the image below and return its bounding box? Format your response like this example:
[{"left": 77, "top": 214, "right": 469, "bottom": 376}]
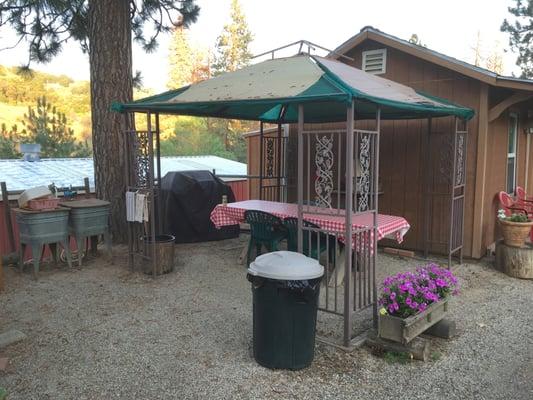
[{"left": 0, "top": 237, "right": 533, "bottom": 400}]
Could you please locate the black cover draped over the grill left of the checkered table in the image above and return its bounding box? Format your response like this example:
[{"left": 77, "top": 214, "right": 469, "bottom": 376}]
[{"left": 161, "top": 171, "right": 239, "bottom": 243}]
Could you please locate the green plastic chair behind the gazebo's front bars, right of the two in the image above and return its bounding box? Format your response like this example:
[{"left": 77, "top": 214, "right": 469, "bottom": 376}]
[{"left": 283, "top": 217, "right": 336, "bottom": 263}]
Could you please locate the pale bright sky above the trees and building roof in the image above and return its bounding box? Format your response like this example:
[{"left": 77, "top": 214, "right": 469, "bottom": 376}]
[{"left": 0, "top": 0, "right": 519, "bottom": 91}]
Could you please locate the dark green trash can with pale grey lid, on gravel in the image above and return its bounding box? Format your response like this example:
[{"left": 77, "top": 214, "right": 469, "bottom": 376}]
[{"left": 247, "top": 251, "right": 324, "bottom": 369}]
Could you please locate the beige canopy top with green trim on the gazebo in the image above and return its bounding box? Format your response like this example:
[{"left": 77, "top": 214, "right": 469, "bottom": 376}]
[{"left": 113, "top": 54, "right": 474, "bottom": 123}]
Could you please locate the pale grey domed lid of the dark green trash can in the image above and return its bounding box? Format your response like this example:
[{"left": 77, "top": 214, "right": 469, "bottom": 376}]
[{"left": 248, "top": 251, "right": 324, "bottom": 281}]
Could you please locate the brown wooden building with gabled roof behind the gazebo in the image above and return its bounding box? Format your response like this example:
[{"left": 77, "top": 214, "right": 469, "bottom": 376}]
[{"left": 247, "top": 27, "right": 533, "bottom": 258}]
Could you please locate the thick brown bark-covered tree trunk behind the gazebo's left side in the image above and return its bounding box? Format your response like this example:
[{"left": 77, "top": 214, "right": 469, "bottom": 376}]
[{"left": 89, "top": 0, "right": 133, "bottom": 242}]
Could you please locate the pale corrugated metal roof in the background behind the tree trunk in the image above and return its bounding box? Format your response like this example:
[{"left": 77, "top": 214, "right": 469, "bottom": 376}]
[{"left": 0, "top": 156, "right": 247, "bottom": 190}]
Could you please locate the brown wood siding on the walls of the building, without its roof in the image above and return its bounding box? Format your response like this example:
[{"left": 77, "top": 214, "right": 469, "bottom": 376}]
[{"left": 244, "top": 40, "right": 533, "bottom": 257}]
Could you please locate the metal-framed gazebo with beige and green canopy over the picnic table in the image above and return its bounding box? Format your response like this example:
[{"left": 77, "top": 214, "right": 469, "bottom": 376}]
[{"left": 113, "top": 49, "right": 474, "bottom": 347}]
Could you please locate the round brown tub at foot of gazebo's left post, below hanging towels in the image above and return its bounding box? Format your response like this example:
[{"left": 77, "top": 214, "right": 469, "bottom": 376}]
[{"left": 142, "top": 235, "right": 176, "bottom": 275}]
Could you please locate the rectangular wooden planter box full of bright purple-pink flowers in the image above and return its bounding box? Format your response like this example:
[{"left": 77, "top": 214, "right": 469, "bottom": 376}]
[{"left": 378, "top": 264, "right": 458, "bottom": 344}]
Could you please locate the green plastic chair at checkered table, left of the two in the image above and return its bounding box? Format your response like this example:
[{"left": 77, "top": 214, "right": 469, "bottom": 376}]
[{"left": 244, "top": 210, "right": 287, "bottom": 265}]
